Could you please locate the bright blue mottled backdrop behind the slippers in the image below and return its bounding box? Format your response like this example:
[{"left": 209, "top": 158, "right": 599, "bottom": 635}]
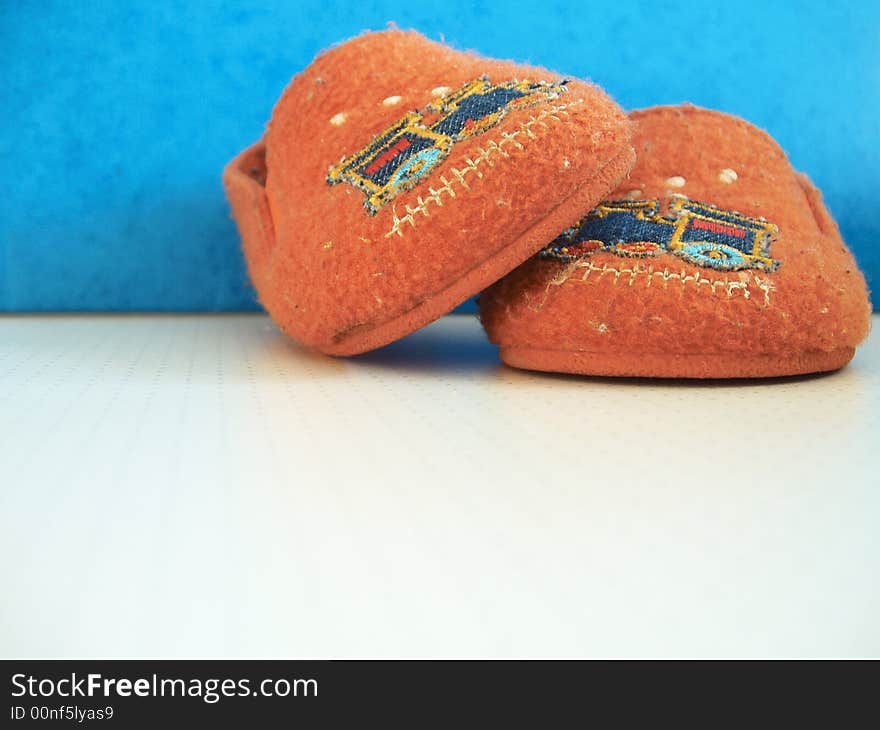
[{"left": 0, "top": 0, "right": 880, "bottom": 310}]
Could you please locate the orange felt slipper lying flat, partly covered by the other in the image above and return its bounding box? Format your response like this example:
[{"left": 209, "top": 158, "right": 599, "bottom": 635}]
[{"left": 480, "top": 106, "right": 871, "bottom": 378}]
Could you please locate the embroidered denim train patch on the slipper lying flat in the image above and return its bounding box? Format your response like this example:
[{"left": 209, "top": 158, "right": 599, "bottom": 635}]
[{"left": 540, "top": 195, "right": 779, "bottom": 271}]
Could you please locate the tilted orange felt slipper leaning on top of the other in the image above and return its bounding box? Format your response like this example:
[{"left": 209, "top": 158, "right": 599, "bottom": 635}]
[{"left": 224, "top": 30, "right": 634, "bottom": 355}]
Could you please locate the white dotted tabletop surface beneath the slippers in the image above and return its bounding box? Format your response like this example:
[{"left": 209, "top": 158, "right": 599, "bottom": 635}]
[{"left": 0, "top": 315, "right": 880, "bottom": 657}]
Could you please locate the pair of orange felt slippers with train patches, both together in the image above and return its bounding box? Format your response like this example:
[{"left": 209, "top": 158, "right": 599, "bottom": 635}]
[{"left": 224, "top": 31, "right": 870, "bottom": 378}]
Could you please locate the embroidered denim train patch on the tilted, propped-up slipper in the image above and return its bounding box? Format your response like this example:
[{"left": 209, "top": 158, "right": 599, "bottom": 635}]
[{"left": 327, "top": 77, "right": 566, "bottom": 215}]
